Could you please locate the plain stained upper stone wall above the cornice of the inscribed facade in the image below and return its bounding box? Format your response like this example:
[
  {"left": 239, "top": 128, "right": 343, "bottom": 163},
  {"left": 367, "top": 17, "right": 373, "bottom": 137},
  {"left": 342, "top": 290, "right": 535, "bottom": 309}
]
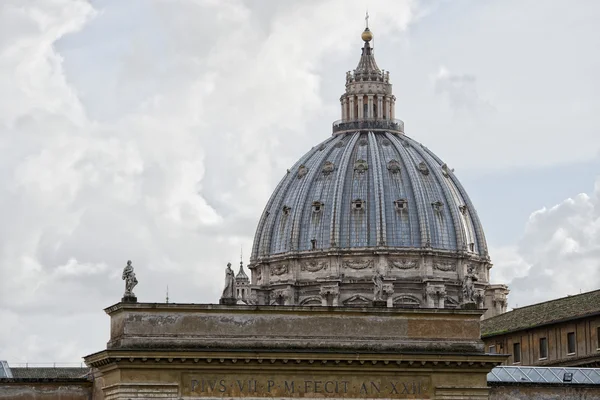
[{"left": 107, "top": 303, "right": 484, "bottom": 354}]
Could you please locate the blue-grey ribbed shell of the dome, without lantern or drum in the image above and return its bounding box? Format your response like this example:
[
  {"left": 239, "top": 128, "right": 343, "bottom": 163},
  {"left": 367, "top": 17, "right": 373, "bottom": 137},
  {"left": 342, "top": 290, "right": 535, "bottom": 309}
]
[{"left": 252, "top": 131, "right": 488, "bottom": 261}]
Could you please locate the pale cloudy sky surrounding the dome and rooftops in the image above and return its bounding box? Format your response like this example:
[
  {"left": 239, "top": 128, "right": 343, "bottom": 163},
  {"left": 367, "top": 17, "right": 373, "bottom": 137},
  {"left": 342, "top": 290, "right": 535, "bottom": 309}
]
[{"left": 0, "top": 0, "right": 600, "bottom": 364}]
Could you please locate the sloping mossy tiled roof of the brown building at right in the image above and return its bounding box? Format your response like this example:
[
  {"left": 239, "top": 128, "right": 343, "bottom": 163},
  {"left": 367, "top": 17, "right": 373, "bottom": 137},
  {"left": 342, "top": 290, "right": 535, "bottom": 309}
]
[{"left": 481, "top": 290, "right": 600, "bottom": 337}]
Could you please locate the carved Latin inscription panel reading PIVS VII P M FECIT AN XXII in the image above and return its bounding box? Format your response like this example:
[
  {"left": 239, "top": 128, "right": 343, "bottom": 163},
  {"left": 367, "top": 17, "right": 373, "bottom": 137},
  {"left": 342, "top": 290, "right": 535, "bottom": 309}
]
[{"left": 182, "top": 374, "right": 430, "bottom": 399}]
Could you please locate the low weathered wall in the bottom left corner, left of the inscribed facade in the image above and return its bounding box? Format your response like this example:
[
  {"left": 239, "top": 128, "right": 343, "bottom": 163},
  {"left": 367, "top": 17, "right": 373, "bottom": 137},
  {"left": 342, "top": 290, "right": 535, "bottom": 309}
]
[{"left": 0, "top": 379, "right": 92, "bottom": 400}]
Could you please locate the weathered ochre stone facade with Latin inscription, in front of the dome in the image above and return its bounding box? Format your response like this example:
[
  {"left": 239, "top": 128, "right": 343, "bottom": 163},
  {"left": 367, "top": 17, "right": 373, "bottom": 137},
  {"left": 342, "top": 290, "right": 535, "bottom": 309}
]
[{"left": 85, "top": 303, "right": 505, "bottom": 400}]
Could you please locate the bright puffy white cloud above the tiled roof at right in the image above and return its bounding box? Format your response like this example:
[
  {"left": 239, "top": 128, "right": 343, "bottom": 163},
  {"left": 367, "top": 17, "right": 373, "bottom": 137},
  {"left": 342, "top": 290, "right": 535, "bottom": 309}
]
[{"left": 491, "top": 178, "right": 600, "bottom": 307}]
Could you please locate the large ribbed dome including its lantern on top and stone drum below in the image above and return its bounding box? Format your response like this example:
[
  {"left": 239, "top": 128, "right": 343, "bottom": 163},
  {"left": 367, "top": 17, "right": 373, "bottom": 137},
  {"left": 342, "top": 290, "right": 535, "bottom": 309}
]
[{"left": 239, "top": 25, "right": 508, "bottom": 315}]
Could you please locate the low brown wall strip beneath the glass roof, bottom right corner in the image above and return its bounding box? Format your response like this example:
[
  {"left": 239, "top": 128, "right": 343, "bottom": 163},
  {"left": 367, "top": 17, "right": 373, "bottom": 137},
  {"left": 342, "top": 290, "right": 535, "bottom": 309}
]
[{"left": 490, "top": 385, "right": 600, "bottom": 400}]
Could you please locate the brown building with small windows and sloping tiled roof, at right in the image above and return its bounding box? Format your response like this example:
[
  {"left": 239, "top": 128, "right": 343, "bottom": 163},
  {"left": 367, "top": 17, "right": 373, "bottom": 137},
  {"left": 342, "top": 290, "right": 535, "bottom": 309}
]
[{"left": 481, "top": 290, "right": 600, "bottom": 367}]
